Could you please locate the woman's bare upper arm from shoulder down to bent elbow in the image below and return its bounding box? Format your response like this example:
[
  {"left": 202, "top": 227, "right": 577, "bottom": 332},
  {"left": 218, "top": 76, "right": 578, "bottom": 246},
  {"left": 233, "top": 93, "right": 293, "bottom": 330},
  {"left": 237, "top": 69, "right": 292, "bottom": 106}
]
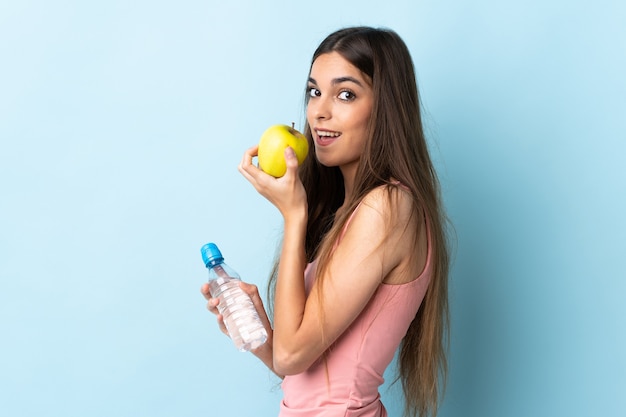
[{"left": 280, "top": 188, "right": 414, "bottom": 371}]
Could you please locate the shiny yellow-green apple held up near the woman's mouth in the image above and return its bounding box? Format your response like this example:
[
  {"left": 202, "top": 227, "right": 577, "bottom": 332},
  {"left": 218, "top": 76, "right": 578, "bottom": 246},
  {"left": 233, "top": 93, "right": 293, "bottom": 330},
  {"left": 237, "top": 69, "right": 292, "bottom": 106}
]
[{"left": 258, "top": 125, "right": 309, "bottom": 178}]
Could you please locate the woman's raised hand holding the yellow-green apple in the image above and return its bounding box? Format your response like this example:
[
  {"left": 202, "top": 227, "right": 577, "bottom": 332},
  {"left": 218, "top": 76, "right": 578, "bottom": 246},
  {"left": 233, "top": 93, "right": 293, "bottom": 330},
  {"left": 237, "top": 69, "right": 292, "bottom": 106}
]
[{"left": 238, "top": 145, "right": 307, "bottom": 219}]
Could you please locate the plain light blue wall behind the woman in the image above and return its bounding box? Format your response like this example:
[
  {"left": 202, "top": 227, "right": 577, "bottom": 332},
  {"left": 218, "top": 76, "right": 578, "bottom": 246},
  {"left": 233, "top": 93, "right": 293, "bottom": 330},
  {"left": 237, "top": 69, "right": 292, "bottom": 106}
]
[{"left": 0, "top": 0, "right": 626, "bottom": 417}]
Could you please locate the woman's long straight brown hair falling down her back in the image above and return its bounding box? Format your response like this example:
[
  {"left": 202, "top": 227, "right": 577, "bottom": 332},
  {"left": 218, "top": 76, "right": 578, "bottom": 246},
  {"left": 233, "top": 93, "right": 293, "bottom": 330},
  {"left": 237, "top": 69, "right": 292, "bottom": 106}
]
[{"left": 268, "top": 27, "right": 449, "bottom": 417}]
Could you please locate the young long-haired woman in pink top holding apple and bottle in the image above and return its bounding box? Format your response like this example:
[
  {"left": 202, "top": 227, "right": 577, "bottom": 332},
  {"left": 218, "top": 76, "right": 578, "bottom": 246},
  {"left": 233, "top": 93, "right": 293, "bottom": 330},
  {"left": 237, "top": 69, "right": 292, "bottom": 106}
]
[{"left": 202, "top": 27, "right": 448, "bottom": 417}]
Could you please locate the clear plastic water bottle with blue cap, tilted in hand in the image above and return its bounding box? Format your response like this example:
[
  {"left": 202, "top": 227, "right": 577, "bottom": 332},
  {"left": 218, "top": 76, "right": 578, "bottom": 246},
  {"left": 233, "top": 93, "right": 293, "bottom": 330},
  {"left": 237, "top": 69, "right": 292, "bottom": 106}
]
[{"left": 200, "top": 243, "right": 267, "bottom": 352}]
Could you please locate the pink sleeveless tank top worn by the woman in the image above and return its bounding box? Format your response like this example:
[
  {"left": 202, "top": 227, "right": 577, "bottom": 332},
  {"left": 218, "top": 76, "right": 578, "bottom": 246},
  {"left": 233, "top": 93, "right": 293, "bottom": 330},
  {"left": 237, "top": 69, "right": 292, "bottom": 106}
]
[{"left": 279, "top": 203, "right": 432, "bottom": 417}]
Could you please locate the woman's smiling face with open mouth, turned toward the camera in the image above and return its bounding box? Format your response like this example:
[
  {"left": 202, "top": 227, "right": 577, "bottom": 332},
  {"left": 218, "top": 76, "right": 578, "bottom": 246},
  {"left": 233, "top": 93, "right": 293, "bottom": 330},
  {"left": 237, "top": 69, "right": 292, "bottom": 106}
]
[{"left": 307, "top": 52, "right": 374, "bottom": 176}]
